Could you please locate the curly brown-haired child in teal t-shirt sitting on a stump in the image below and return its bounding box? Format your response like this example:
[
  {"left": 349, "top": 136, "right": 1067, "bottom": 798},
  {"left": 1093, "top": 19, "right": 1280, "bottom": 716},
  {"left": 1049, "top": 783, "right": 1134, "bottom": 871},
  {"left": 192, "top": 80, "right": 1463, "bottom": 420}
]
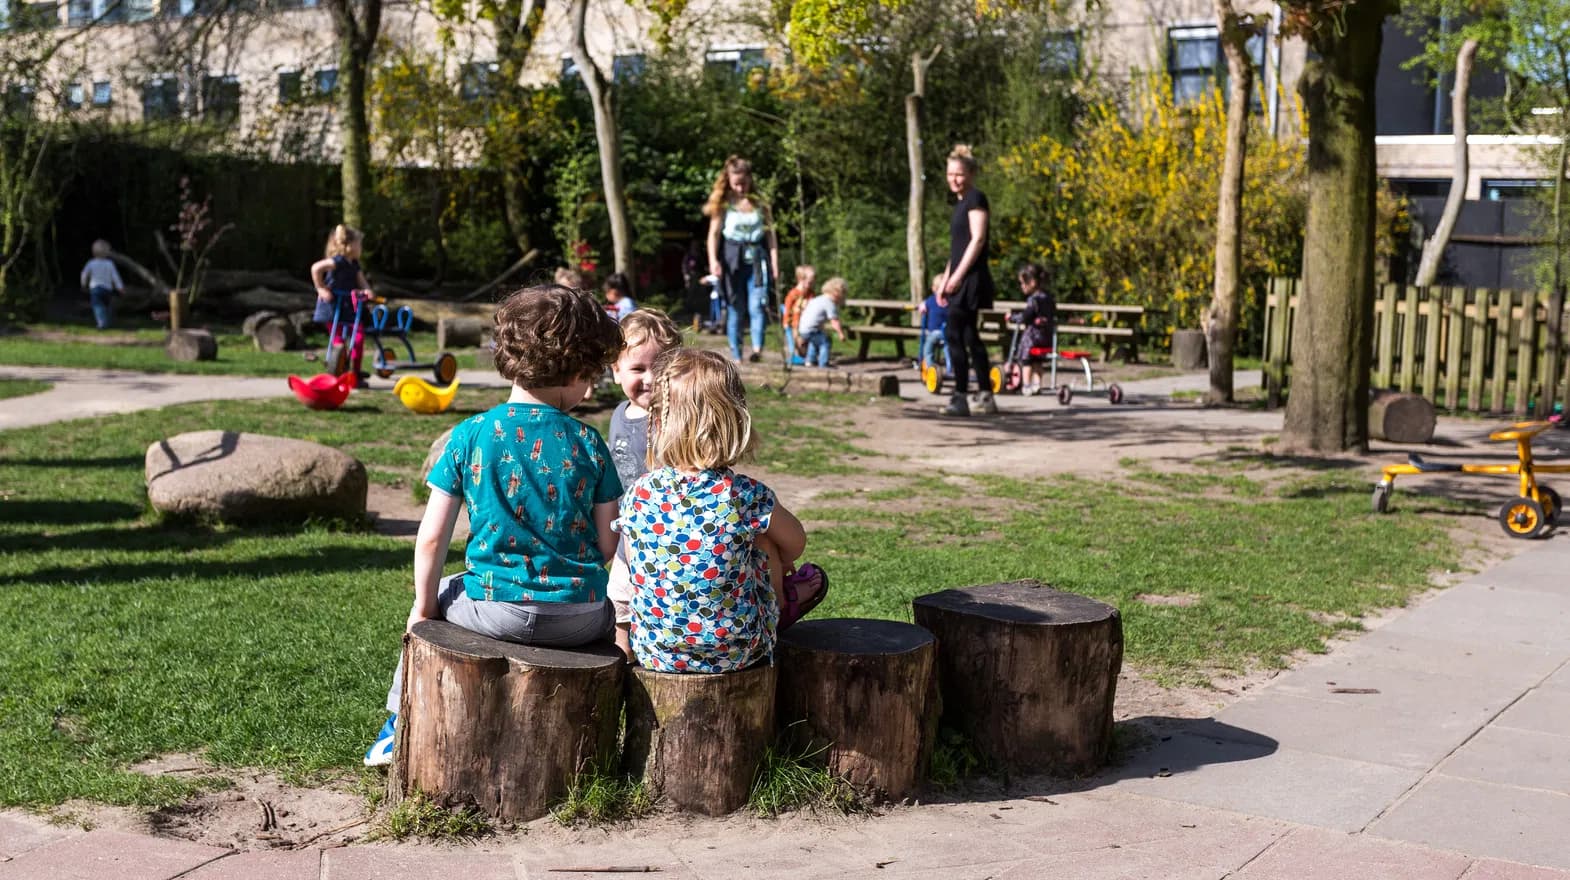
[{"left": 366, "top": 285, "right": 622, "bottom": 767}]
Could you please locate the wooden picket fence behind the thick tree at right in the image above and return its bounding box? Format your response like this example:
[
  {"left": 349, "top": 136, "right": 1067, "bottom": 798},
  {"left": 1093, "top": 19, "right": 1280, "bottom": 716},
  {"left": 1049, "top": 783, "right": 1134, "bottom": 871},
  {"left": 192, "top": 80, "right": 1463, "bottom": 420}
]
[{"left": 1264, "top": 278, "right": 1570, "bottom": 416}]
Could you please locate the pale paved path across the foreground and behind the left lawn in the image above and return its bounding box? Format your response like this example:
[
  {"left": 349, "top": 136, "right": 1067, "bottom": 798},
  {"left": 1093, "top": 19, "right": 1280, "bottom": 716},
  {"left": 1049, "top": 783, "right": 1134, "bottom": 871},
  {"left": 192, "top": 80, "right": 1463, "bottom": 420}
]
[{"left": 0, "top": 367, "right": 1570, "bottom": 880}]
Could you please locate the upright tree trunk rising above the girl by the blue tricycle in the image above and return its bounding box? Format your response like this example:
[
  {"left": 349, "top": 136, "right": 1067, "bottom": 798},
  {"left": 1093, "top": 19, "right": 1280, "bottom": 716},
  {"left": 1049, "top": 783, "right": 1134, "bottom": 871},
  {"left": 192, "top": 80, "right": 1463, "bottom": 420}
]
[{"left": 327, "top": 0, "right": 383, "bottom": 229}]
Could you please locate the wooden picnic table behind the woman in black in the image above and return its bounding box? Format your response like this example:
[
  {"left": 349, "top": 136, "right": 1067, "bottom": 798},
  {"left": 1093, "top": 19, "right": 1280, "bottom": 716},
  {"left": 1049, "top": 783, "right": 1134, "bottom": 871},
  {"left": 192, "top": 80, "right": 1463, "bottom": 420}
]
[{"left": 845, "top": 300, "right": 1149, "bottom": 362}]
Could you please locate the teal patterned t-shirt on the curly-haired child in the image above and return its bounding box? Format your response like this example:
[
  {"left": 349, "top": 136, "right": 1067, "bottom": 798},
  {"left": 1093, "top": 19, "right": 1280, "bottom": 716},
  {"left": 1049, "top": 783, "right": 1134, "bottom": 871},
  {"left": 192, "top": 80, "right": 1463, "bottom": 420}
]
[{"left": 427, "top": 403, "right": 622, "bottom": 602}]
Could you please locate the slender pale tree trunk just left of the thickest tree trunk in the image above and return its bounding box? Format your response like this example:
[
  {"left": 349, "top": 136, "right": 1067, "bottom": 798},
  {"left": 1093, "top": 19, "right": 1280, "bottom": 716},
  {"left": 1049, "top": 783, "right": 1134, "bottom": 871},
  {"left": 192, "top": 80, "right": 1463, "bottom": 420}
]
[{"left": 1204, "top": 0, "right": 1254, "bottom": 403}]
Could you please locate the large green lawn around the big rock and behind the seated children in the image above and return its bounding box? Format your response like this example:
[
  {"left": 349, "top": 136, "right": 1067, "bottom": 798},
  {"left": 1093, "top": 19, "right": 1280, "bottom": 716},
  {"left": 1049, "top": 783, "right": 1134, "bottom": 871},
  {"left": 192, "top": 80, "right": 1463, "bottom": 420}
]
[{"left": 0, "top": 384, "right": 1455, "bottom": 806}]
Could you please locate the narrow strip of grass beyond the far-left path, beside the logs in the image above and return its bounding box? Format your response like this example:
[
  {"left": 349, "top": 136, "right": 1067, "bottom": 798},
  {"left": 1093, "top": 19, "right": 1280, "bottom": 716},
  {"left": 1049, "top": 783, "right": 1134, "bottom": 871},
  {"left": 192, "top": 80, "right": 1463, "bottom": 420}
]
[{"left": 0, "top": 325, "right": 474, "bottom": 376}]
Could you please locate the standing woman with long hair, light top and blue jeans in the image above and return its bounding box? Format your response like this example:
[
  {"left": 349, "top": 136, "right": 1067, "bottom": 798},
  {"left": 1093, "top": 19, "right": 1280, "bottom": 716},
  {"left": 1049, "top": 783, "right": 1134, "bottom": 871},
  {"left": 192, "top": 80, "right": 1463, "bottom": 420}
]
[{"left": 703, "top": 155, "right": 780, "bottom": 361}]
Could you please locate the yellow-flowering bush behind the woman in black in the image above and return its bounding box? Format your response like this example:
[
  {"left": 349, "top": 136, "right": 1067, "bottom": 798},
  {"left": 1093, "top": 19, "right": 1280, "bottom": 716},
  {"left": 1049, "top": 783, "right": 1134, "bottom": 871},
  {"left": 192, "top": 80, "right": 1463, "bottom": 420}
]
[{"left": 994, "top": 80, "right": 1308, "bottom": 340}]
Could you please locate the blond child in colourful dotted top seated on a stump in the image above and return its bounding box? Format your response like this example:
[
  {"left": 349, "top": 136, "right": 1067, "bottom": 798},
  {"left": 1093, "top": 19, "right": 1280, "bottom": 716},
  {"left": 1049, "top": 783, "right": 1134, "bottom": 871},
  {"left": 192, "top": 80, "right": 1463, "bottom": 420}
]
[{"left": 612, "top": 348, "right": 829, "bottom": 673}]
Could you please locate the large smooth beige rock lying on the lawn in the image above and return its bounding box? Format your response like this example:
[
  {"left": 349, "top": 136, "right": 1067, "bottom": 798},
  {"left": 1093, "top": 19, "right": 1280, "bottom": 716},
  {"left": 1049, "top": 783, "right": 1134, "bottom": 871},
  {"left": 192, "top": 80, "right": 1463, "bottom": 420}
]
[{"left": 146, "top": 431, "right": 366, "bottom": 522}]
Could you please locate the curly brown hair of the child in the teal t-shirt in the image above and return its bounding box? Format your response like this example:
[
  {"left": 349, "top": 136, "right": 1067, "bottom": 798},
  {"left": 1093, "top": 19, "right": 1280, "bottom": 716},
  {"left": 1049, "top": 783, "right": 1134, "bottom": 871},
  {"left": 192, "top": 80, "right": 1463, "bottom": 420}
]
[{"left": 496, "top": 284, "right": 622, "bottom": 387}]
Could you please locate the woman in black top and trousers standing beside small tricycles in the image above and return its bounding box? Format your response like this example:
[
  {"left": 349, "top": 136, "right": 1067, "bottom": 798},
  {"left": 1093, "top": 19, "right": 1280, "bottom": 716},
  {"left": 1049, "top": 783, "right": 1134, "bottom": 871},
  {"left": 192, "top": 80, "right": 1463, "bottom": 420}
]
[{"left": 937, "top": 144, "right": 997, "bottom": 416}]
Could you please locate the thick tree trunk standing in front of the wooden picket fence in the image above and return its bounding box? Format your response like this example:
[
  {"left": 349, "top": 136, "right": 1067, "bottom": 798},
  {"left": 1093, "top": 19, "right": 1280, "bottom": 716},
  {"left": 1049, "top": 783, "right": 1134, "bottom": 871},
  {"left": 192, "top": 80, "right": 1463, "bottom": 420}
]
[{"left": 1281, "top": 8, "right": 1394, "bottom": 452}]
